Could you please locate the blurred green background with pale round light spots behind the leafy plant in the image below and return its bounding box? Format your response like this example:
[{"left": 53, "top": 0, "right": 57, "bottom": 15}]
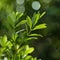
[{"left": 0, "top": 0, "right": 60, "bottom": 60}]
